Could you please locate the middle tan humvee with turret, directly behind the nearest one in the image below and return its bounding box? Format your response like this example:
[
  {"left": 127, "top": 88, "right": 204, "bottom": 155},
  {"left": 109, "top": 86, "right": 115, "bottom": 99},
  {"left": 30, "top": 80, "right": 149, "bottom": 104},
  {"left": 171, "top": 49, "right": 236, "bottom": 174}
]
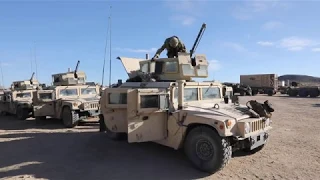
[{"left": 33, "top": 61, "right": 100, "bottom": 128}]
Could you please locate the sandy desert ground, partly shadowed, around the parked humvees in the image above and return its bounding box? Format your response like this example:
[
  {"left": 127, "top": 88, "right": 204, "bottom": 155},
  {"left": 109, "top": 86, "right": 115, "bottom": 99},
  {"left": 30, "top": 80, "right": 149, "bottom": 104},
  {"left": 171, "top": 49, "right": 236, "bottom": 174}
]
[{"left": 0, "top": 95, "right": 320, "bottom": 180}]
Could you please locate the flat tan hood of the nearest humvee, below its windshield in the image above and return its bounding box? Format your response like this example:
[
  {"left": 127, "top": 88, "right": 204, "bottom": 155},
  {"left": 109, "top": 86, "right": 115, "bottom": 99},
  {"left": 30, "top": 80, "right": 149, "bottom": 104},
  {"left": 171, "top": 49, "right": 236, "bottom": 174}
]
[{"left": 183, "top": 103, "right": 251, "bottom": 121}]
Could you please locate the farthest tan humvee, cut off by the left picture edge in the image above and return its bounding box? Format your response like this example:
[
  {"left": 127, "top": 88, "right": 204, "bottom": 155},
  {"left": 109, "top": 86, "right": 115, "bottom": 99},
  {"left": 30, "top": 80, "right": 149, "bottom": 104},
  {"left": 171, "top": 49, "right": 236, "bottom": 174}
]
[{"left": 0, "top": 73, "right": 41, "bottom": 120}]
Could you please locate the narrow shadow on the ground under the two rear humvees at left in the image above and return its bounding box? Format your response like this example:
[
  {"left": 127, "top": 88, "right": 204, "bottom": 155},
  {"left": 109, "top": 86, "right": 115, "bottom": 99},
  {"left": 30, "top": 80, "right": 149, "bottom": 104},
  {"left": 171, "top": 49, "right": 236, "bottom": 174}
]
[{"left": 0, "top": 115, "right": 99, "bottom": 130}]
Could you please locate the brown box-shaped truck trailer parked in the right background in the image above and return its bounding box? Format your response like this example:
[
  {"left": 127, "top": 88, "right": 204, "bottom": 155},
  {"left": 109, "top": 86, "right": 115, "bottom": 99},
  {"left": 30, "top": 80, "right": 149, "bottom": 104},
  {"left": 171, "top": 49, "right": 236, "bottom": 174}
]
[{"left": 240, "top": 74, "right": 278, "bottom": 96}]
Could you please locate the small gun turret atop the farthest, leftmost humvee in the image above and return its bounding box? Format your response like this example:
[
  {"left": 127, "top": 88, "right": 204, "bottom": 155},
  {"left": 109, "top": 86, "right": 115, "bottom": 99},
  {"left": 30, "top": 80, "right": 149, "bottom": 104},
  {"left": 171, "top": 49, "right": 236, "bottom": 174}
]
[{"left": 11, "top": 73, "right": 40, "bottom": 91}]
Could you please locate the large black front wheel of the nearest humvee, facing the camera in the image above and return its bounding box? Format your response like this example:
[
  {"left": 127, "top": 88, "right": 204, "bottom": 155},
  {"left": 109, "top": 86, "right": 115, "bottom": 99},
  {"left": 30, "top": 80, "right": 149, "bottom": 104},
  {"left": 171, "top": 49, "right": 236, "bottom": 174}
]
[{"left": 184, "top": 126, "right": 232, "bottom": 173}]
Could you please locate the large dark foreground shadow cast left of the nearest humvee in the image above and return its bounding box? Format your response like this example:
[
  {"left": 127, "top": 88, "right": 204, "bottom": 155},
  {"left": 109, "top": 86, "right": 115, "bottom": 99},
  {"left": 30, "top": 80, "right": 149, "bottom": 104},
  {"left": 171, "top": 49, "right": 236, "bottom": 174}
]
[{"left": 0, "top": 132, "right": 209, "bottom": 180}]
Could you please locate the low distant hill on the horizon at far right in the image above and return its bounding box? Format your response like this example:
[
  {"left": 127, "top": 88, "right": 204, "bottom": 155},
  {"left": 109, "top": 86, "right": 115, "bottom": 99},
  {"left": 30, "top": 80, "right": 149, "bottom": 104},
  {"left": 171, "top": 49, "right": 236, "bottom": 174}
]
[{"left": 278, "top": 74, "right": 320, "bottom": 84}]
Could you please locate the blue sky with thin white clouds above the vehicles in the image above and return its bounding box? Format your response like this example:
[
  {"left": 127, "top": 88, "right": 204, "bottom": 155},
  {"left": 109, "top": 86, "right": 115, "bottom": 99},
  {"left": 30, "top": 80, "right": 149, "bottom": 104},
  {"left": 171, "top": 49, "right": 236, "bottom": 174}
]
[{"left": 0, "top": 0, "right": 320, "bottom": 86}]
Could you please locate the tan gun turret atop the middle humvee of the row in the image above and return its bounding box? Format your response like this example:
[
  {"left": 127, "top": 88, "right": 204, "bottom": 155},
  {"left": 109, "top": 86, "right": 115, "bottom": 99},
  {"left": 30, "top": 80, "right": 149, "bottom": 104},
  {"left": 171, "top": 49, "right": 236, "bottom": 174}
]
[{"left": 52, "top": 61, "right": 87, "bottom": 86}]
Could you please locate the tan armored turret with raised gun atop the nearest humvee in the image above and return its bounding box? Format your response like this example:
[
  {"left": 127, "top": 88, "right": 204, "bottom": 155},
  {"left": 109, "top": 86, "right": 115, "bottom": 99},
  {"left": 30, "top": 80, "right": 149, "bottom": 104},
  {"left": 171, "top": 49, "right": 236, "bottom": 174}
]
[{"left": 117, "top": 23, "right": 209, "bottom": 82}]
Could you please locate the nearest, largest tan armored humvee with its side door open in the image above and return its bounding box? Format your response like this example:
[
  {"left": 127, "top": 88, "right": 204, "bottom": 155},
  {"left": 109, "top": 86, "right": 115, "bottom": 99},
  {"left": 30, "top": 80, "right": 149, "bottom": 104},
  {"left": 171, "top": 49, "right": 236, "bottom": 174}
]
[{"left": 100, "top": 23, "right": 273, "bottom": 173}]
